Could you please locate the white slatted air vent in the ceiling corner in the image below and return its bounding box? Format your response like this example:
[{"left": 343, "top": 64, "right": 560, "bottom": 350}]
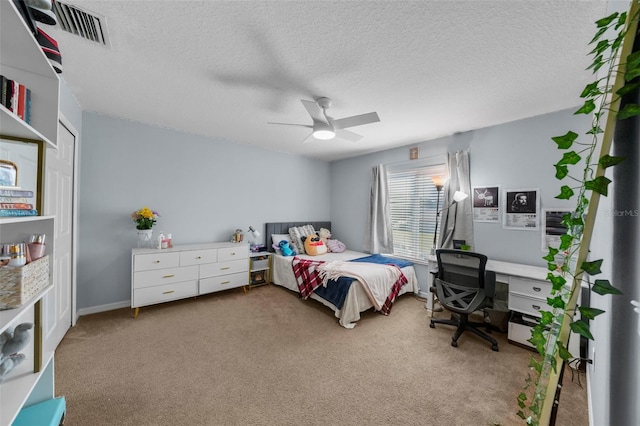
[{"left": 53, "top": 1, "right": 111, "bottom": 48}]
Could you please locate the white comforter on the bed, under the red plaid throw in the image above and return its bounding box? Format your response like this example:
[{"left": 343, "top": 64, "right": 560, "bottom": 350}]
[{"left": 272, "top": 250, "right": 419, "bottom": 328}]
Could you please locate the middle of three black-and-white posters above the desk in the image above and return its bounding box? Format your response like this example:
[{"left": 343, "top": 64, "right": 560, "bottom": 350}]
[{"left": 502, "top": 188, "right": 540, "bottom": 231}]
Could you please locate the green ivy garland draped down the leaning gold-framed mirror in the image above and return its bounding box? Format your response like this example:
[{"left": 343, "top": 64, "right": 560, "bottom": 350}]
[{"left": 517, "top": 0, "right": 640, "bottom": 425}]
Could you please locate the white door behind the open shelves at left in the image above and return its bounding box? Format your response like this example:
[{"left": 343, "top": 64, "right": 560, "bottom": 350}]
[{"left": 43, "top": 118, "right": 77, "bottom": 350}]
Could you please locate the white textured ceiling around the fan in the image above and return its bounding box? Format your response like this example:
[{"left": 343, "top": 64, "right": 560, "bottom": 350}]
[{"left": 48, "top": 0, "right": 607, "bottom": 160}]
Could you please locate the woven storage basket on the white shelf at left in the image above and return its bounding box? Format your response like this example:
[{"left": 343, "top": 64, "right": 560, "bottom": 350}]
[{"left": 0, "top": 256, "right": 49, "bottom": 309}]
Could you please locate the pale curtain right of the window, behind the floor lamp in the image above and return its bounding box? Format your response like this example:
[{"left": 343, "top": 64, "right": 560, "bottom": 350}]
[{"left": 438, "top": 149, "right": 473, "bottom": 250}]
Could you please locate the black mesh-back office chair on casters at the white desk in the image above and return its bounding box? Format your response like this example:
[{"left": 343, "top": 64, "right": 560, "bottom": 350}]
[{"left": 429, "top": 249, "right": 498, "bottom": 351}]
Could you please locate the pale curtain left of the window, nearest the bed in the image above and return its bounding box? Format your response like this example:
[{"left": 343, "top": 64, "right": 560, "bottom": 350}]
[{"left": 368, "top": 164, "right": 393, "bottom": 254}]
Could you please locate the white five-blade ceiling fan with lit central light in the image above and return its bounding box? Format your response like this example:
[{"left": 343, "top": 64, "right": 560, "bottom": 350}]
[{"left": 268, "top": 98, "right": 380, "bottom": 143}]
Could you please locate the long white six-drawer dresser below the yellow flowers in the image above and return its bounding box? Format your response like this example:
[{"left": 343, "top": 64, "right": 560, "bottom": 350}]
[{"left": 131, "top": 242, "right": 249, "bottom": 318}]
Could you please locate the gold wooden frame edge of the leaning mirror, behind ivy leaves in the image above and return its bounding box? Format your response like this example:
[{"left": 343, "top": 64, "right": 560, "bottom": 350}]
[{"left": 536, "top": 0, "right": 640, "bottom": 425}]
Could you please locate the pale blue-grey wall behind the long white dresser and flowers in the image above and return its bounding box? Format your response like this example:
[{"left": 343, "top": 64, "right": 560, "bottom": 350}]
[{"left": 77, "top": 112, "right": 330, "bottom": 309}]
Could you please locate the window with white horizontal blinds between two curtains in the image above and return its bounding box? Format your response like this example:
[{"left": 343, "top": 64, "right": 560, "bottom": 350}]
[{"left": 387, "top": 157, "right": 447, "bottom": 259}]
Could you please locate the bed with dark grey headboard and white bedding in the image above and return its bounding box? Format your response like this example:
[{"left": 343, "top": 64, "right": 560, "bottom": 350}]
[{"left": 265, "top": 221, "right": 419, "bottom": 329}]
